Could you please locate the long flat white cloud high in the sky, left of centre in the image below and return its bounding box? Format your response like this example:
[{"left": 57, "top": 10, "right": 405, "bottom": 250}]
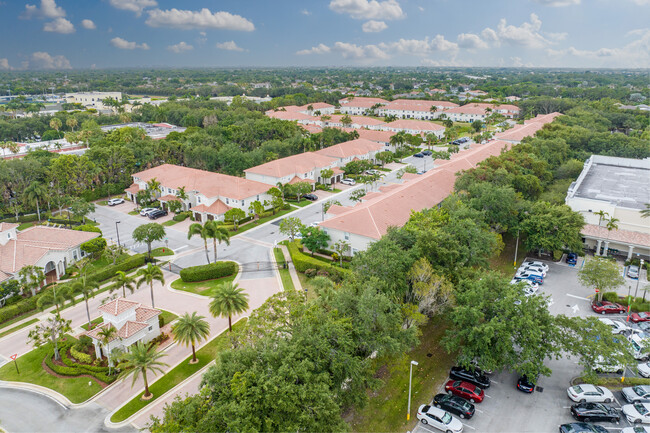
[{"left": 145, "top": 8, "right": 255, "bottom": 32}]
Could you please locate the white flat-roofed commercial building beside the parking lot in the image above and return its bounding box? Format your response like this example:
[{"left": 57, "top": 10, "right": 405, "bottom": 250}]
[{"left": 565, "top": 155, "right": 650, "bottom": 259}]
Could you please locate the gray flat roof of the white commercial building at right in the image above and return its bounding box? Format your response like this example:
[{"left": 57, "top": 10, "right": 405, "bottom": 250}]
[{"left": 575, "top": 162, "right": 650, "bottom": 209}]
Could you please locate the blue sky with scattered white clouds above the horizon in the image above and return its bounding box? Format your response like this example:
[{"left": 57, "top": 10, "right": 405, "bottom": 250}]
[{"left": 0, "top": 0, "right": 650, "bottom": 70}]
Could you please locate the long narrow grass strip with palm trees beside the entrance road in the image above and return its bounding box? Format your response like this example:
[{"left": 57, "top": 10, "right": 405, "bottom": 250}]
[{"left": 111, "top": 319, "right": 246, "bottom": 422}]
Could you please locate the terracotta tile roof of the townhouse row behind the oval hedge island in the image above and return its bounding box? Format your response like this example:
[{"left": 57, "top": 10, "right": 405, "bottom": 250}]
[{"left": 132, "top": 164, "right": 269, "bottom": 200}]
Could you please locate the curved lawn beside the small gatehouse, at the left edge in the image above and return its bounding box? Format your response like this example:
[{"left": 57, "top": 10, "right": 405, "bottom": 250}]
[{"left": 0, "top": 337, "right": 102, "bottom": 403}]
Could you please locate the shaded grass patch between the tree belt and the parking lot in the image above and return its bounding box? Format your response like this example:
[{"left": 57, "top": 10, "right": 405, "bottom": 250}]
[{"left": 346, "top": 317, "right": 456, "bottom": 432}]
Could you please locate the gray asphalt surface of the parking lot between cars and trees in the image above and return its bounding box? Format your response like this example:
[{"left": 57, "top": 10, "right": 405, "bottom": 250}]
[{"left": 413, "top": 258, "right": 637, "bottom": 433}]
